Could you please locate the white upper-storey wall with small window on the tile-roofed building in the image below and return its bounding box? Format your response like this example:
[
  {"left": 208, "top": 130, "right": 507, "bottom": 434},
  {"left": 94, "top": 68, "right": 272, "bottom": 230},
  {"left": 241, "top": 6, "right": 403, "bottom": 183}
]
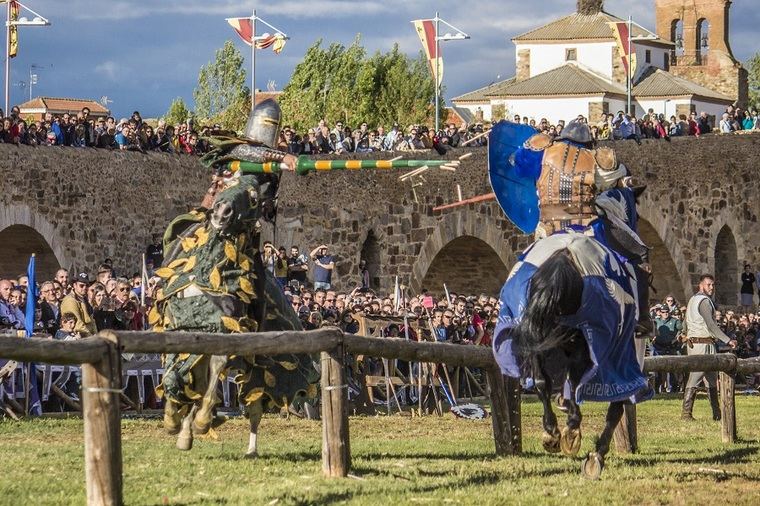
[{"left": 515, "top": 42, "right": 615, "bottom": 79}]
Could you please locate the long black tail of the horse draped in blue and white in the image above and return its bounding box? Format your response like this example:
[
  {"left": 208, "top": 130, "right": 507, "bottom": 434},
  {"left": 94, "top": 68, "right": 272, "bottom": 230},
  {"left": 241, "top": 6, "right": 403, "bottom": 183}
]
[{"left": 512, "top": 249, "right": 583, "bottom": 357}]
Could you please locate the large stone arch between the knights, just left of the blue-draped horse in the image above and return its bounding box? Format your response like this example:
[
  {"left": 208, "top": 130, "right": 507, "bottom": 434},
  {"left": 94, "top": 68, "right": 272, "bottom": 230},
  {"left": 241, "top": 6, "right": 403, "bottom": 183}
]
[{"left": 410, "top": 211, "right": 515, "bottom": 293}]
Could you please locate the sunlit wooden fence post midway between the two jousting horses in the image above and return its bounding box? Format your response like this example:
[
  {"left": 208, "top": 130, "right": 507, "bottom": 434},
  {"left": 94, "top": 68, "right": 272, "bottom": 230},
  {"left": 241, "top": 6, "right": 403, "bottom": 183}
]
[{"left": 321, "top": 343, "right": 351, "bottom": 478}]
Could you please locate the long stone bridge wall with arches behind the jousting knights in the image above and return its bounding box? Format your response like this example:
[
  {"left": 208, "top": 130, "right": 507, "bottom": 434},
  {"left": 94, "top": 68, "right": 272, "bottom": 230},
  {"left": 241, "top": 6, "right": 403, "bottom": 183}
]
[{"left": 0, "top": 135, "right": 760, "bottom": 305}]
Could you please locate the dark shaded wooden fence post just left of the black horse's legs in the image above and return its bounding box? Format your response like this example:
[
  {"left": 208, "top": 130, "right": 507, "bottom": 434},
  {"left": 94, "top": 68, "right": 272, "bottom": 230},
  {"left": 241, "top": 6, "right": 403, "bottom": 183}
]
[{"left": 487, "top": 368, "right": 522, "bottom": 456}]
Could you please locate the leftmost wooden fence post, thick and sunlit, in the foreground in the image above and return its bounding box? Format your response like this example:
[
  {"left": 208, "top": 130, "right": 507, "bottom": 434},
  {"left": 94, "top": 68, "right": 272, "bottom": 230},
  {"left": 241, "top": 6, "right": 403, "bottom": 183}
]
[{"left": 82, "top": 332, "right": 123, "bottom": 506}]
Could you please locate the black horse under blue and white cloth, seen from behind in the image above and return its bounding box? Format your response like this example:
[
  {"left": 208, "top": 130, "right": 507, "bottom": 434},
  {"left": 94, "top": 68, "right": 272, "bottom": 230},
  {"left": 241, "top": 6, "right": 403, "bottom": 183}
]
[{"left": 497, "top": 238, "right": 640, "bottom": 479}]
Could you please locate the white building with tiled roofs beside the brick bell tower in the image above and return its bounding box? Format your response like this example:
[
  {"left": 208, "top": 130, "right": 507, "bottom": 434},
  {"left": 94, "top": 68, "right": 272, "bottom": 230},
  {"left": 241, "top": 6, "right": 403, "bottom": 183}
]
[{"left": 452, "top": 2, "right": 734, "bottom": 123}]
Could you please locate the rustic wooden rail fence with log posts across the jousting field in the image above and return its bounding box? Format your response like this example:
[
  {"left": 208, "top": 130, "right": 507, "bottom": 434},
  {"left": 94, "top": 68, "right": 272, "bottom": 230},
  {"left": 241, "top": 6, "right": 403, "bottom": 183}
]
[{"left": 0, "top": 329, "right": 760, "bottom": 505}]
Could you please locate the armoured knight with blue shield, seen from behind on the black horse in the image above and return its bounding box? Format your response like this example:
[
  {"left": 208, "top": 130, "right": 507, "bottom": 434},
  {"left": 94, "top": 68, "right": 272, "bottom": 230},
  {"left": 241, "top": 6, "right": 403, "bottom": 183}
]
[{"left": 489, "top": 116, "right": 652, "bottom": 333}]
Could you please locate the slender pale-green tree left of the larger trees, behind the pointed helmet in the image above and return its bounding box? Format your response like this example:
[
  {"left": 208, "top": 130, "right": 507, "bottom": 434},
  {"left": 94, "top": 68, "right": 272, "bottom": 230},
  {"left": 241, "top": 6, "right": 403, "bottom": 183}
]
[{"left": 193, "top": 40, "right": 251, "bottom": 128}]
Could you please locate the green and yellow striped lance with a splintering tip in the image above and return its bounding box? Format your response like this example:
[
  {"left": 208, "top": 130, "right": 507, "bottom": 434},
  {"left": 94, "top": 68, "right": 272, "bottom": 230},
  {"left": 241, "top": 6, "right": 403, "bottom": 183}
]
[{"left": 220, "top": 155, "right": 459, "bottom": 175}]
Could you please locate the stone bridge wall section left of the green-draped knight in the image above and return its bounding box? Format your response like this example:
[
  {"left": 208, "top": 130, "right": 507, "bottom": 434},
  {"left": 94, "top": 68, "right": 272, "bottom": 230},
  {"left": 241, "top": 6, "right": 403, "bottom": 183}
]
[{"left": 0, "top": 144, "right": 209, "bottom": 276}]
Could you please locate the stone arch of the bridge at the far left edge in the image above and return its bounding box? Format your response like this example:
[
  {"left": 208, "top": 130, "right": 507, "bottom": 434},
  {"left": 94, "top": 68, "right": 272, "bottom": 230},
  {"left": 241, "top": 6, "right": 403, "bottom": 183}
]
[{"left": 0, "top": 205, "right": 72, "bottom": 280}]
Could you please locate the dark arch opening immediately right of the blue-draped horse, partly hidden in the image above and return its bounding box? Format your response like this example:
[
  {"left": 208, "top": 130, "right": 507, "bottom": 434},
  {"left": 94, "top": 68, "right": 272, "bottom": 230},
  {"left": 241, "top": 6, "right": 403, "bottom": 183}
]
[{"left": 639, "top": 219, "right": 690, "bottom": 304}]
